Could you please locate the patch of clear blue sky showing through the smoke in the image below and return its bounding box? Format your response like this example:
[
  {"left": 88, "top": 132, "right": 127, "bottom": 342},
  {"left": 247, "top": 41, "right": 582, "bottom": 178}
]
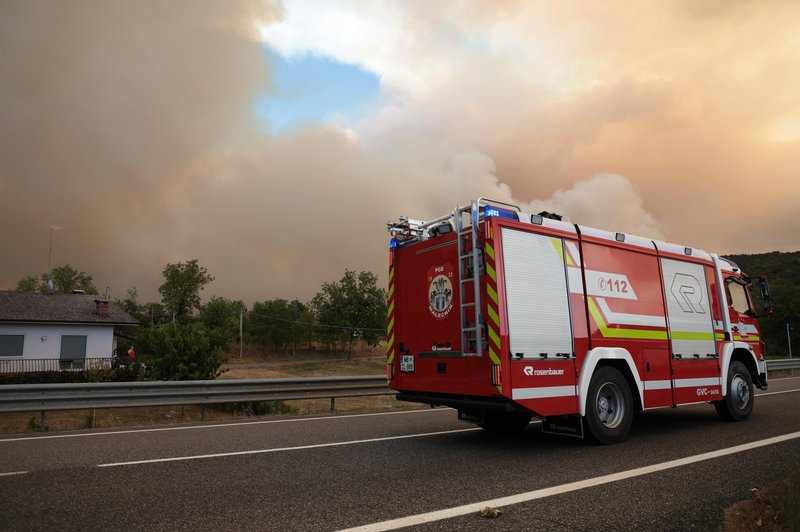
[{"left": 255, "top": 47, "right": 380, "bottom": 133}]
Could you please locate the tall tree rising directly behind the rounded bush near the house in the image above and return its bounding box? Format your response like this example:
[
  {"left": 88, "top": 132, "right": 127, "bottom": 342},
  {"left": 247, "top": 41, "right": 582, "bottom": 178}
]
[{"left": 158, "top": 259, "right": 214, "bottom": 320}]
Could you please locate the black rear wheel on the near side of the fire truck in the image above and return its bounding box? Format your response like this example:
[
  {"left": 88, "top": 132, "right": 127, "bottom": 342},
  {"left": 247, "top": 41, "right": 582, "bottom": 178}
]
[{"left": 584, "top": 366, "right": 633, "bottom": 445}]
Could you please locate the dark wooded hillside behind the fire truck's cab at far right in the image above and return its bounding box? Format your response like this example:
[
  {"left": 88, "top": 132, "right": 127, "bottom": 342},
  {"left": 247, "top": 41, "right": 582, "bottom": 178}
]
[{"left": 724, "top": 251, "right": 800, "bottom": 357}]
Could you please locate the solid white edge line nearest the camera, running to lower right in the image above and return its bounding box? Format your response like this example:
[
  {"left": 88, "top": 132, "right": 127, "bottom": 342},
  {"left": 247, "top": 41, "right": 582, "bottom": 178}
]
[{"left": 342, "top": 432, "right": 800, "bottom": 532}]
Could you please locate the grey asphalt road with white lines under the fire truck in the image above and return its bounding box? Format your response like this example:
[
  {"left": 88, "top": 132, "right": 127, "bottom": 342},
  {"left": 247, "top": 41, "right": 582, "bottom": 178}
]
[{"left": 0, "top": 378, "right": 800, "bottom": 531}]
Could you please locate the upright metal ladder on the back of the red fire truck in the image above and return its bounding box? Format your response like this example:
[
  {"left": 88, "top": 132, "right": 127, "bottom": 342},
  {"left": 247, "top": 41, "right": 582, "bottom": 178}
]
[{"left": 453, "top": 201, "right": 484, "bottom": 356}]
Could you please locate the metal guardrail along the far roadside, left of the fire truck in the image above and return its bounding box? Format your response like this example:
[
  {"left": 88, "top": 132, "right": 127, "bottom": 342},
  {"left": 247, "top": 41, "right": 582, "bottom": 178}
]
[{"left": 0, "top": 375, "right": 395, "bottom": 412}]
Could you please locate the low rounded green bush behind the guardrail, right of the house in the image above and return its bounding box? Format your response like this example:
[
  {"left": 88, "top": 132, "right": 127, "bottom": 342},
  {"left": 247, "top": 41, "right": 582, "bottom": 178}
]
[{"left": 138, "top": 322, "right": 224, "bottom": 381}]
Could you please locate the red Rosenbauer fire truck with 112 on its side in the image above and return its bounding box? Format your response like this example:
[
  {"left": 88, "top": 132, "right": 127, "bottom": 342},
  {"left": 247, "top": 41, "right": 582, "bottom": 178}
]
[{"left": 386, "top": 199, "right": 771, "bottom": 444}]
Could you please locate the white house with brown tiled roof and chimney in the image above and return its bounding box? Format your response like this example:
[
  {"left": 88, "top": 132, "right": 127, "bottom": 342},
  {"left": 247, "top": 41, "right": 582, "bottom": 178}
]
[{"left": 0, "top": 291, "right": 139, "bottom": 372}]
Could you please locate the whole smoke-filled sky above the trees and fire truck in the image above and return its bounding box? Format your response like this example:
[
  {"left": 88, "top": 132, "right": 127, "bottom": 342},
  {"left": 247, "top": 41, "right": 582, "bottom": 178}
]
[{"left": 0, "top": 0, "right": 800, "bottom": 304}]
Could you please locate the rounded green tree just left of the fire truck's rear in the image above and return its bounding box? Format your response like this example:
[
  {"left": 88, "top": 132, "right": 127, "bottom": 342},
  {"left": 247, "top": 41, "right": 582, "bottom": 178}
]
[{"left": 311, "top": 270, "right": 386, "bottom": 360}]
